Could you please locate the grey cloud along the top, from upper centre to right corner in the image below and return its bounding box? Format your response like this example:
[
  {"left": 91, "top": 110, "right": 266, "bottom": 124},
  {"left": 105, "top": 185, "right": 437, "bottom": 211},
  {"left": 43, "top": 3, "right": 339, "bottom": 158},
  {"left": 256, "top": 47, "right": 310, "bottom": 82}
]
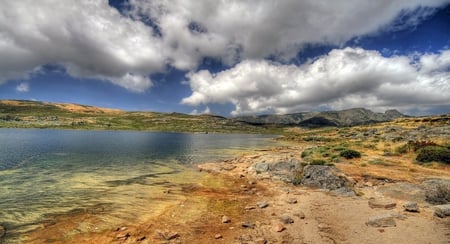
[{"left": 130, "top": 0, "right": 448, "bottom": 63}]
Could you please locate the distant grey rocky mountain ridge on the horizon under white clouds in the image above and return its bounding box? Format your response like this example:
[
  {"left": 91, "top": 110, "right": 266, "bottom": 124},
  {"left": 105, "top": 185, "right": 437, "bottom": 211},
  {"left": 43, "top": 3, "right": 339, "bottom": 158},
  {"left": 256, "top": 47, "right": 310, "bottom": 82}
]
[{"left": 235, "top": 108, "right": 406, "bottom": 127}]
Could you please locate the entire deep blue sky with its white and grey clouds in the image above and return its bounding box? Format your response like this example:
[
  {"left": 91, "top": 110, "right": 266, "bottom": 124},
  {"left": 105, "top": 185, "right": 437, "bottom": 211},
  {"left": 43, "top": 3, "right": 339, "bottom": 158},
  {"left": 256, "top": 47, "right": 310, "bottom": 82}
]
[{"left": 0, "top": 0, "right": 450, "bottom": 116}]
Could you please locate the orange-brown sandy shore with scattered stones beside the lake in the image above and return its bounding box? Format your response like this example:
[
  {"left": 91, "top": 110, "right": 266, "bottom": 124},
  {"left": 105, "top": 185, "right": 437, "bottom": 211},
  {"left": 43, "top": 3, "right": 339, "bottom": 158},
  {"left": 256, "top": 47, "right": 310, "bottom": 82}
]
[{"left": 17, "top": 146, "right": 450, "bottom": 244}]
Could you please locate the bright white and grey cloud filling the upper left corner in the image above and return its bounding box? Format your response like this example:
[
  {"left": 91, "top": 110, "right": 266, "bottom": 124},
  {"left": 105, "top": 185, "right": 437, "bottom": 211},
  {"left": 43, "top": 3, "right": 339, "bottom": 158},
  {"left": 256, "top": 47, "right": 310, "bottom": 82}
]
[{"left": 0, "top": 0, "right": 162, "bottom": 91}]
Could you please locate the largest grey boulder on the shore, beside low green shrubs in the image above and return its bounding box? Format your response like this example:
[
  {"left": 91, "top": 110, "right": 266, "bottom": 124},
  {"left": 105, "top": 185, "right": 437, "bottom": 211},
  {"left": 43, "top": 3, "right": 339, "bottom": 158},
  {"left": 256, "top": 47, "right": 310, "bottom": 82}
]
[{"left": 300, "top": 165, "right": 354, "bottom": 191}]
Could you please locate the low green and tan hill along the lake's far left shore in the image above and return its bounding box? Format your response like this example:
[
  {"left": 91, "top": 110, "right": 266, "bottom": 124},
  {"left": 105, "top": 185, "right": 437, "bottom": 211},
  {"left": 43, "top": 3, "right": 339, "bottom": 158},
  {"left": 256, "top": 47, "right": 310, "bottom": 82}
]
[{"left": 0, "top": 100, "right": 277, "bottom": 133}]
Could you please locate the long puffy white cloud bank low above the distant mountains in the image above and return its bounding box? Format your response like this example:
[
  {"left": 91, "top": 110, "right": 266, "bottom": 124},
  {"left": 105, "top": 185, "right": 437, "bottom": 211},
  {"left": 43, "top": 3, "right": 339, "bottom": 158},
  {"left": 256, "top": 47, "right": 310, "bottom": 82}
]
[{"left": 182, "top": 48, "right": 450, "bottom": 115}]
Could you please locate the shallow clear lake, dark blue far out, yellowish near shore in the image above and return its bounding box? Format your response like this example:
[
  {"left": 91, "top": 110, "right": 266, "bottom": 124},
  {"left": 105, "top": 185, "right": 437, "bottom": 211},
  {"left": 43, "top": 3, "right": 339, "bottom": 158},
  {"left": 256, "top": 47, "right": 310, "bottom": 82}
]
[{"left": 0, "top": 129, "right": 275, "bottom": 242}]
